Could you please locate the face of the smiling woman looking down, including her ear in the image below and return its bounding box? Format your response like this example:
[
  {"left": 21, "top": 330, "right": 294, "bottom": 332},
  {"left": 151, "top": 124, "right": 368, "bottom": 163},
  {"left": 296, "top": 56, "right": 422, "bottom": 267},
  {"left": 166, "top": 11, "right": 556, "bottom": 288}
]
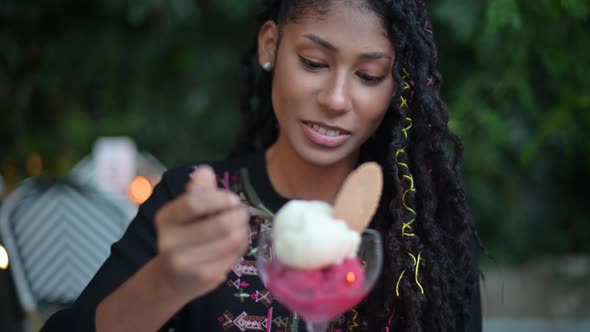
[{"left": 259, "top": 5, "right": 395, "bottom": 166}]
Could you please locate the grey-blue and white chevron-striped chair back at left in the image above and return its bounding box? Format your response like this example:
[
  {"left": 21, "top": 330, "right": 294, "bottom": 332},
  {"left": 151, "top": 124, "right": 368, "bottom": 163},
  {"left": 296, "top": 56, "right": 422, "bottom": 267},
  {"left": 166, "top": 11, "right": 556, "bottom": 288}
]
[{"left": 9, "top": 183, "right": 129, "bottom": 303}]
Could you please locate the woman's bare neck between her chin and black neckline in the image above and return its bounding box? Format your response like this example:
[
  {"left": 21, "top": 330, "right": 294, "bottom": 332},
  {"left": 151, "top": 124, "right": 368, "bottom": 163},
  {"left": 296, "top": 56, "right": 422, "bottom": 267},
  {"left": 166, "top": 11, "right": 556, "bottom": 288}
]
[{"left": 266, "top": 135, "right": 357, "bottom": 204}]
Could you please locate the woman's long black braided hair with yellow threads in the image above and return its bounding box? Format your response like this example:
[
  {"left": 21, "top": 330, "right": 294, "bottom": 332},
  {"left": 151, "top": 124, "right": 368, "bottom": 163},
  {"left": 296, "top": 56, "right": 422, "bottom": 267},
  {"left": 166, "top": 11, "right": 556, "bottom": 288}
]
[{"left": 232, "top": 0, "right": 480, "bottom": 331}]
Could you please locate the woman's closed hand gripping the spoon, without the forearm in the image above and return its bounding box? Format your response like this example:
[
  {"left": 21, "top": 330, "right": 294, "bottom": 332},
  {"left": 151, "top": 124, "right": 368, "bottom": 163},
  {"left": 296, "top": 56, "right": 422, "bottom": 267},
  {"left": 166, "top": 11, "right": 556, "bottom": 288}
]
[{"left": 156, "top": 166, "right": 249, "bottom": 301}]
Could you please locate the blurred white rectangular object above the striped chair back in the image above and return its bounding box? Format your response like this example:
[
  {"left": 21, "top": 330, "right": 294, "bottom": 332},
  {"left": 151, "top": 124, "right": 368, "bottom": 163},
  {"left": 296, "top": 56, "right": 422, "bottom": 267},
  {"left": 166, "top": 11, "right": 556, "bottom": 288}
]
[{"left": 92, "top": 137, "right": 137, "bottom": 195}]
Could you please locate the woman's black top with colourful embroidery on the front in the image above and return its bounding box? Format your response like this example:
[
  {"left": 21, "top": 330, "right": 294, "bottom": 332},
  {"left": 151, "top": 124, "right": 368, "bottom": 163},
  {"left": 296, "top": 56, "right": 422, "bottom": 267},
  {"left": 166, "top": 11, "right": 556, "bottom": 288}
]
[{"left": 41, "top": 151, "right": 481, "bottom": 332}]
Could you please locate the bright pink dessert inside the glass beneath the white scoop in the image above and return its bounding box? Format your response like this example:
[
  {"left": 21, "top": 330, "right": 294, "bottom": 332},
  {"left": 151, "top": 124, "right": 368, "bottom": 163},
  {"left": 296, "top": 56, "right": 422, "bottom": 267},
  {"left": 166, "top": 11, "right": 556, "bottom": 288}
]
[{"left": 266, "top": 258, "right": 367, "bottom": 322}]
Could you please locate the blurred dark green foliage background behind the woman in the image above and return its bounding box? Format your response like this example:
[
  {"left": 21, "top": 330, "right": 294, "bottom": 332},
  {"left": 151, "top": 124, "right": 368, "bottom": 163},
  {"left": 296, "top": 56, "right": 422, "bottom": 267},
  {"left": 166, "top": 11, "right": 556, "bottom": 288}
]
[{"left": 0, "top": 0, "right": 590, "bottom": 331}]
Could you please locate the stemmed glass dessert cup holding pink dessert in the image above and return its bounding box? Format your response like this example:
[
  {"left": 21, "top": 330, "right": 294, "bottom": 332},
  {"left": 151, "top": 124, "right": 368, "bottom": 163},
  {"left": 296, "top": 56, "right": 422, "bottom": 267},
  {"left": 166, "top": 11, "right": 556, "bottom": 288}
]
[{"left": 257, "top": 229, "right": 383, "bottom": 332}]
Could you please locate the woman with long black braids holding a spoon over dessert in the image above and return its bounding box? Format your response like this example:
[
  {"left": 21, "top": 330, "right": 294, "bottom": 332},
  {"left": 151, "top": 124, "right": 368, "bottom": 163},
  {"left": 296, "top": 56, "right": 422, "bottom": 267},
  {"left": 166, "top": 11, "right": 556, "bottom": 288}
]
[{"left": 44, "top": 0, "right": 481, "bottom": 331}]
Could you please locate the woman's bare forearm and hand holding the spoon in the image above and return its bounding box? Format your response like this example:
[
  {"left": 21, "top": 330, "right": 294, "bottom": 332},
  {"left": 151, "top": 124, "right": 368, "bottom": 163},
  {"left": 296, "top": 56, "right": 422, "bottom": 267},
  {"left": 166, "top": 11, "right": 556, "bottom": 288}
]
[{"left": 95, "top": 166, "right": 249, "bottom": 332}]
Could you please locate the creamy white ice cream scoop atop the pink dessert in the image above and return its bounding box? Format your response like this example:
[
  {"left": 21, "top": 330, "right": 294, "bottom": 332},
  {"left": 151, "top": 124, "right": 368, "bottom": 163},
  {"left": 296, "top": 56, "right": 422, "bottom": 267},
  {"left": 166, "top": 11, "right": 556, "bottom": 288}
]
[{"left": 272, "top": 200, "right": 361, "bottom": 269}]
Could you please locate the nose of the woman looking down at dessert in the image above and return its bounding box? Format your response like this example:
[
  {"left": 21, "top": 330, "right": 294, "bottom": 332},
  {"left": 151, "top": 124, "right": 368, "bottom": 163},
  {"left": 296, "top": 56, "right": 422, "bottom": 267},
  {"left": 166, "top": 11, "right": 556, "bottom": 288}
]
[{"left": 318, "top": 73, "right": 352, "bottom": 113}]
